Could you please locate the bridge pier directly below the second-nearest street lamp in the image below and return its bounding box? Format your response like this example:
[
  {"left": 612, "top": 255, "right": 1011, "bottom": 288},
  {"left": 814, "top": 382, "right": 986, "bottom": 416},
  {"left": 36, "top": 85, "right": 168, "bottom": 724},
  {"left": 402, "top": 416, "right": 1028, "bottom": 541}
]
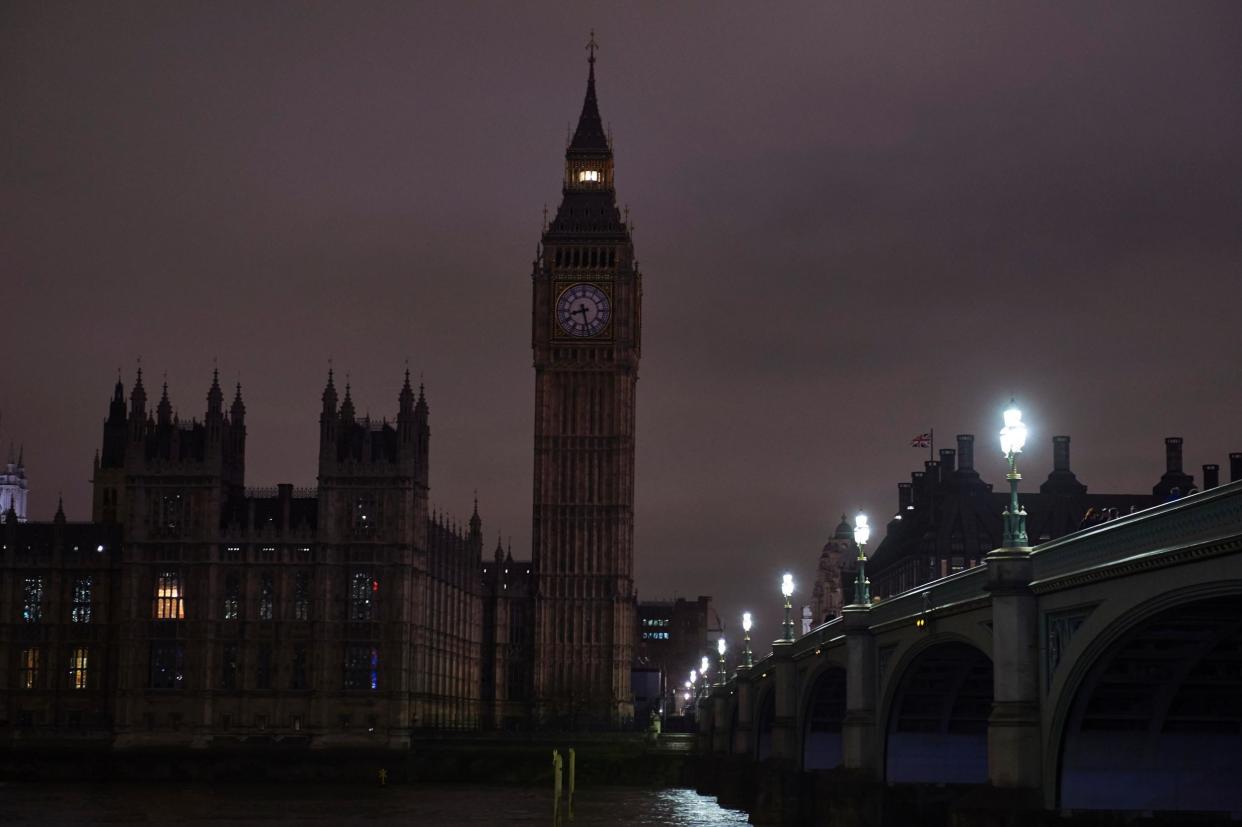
[{"left": 841, "top": 605, "right": 883, "bottom": 779}]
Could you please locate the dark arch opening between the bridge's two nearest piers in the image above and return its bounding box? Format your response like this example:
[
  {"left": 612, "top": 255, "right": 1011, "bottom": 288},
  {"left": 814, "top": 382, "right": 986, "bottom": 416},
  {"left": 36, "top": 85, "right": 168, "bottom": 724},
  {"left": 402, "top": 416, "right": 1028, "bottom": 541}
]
[{"left": 879, "top": 635, "right": 992, "bottom": 784}]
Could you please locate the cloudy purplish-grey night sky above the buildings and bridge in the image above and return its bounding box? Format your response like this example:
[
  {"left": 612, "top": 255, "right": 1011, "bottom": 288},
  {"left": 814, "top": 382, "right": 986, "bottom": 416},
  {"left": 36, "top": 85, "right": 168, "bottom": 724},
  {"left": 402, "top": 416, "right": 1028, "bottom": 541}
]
[{"left": 0, "top": 2, "right": 1242, "bottom": 637}]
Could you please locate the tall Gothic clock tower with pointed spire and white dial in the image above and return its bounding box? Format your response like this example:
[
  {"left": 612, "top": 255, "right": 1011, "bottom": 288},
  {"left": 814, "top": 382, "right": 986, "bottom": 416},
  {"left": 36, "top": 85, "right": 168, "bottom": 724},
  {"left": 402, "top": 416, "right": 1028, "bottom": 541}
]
[{"left": 532, "top": 40, "right": 642, "bottom": 728}]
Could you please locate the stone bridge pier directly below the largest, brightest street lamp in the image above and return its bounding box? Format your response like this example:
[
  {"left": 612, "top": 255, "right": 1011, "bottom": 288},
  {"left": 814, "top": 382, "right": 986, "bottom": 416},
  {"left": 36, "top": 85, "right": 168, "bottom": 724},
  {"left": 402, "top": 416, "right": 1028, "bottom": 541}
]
[{"left": 984, "top": 548, "right": 1043, "bottom": 790}]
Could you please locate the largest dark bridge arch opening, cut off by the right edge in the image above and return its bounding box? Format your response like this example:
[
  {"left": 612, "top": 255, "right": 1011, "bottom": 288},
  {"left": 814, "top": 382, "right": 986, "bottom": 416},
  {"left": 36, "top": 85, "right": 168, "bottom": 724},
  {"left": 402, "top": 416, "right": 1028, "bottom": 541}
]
[{"left": 1048, "top": 580, "right": 1242, "bottom": 812}]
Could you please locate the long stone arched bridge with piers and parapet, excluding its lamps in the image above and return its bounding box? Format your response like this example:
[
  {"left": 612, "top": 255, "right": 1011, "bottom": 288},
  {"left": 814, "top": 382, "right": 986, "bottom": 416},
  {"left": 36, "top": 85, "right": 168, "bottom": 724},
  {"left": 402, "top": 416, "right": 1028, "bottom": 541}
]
[{"left": 698, "top": 482, "right": 1242, "bottom": 817}]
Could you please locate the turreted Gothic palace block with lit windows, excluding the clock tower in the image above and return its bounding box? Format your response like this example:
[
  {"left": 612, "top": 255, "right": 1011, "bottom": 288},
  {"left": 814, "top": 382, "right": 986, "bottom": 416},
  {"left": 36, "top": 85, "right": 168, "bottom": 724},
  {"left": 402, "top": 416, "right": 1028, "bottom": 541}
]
[{"left": 0, "top": 371, "right": 483, "bottom": 748}]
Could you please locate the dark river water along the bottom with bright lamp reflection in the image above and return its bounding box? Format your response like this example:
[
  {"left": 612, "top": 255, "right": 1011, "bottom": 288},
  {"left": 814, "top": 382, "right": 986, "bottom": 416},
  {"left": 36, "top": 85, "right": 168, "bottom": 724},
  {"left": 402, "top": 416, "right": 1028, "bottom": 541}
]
[{"left": 0, "top": 782, "right": 746, "bottom": 827}]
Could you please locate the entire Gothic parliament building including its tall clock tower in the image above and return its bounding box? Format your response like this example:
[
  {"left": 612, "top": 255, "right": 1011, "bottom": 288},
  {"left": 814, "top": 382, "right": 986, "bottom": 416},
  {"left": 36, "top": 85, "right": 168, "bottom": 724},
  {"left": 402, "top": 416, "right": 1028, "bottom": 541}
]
[{"left": 0, "top": 42, "right": 641, "bottom": 749}]
